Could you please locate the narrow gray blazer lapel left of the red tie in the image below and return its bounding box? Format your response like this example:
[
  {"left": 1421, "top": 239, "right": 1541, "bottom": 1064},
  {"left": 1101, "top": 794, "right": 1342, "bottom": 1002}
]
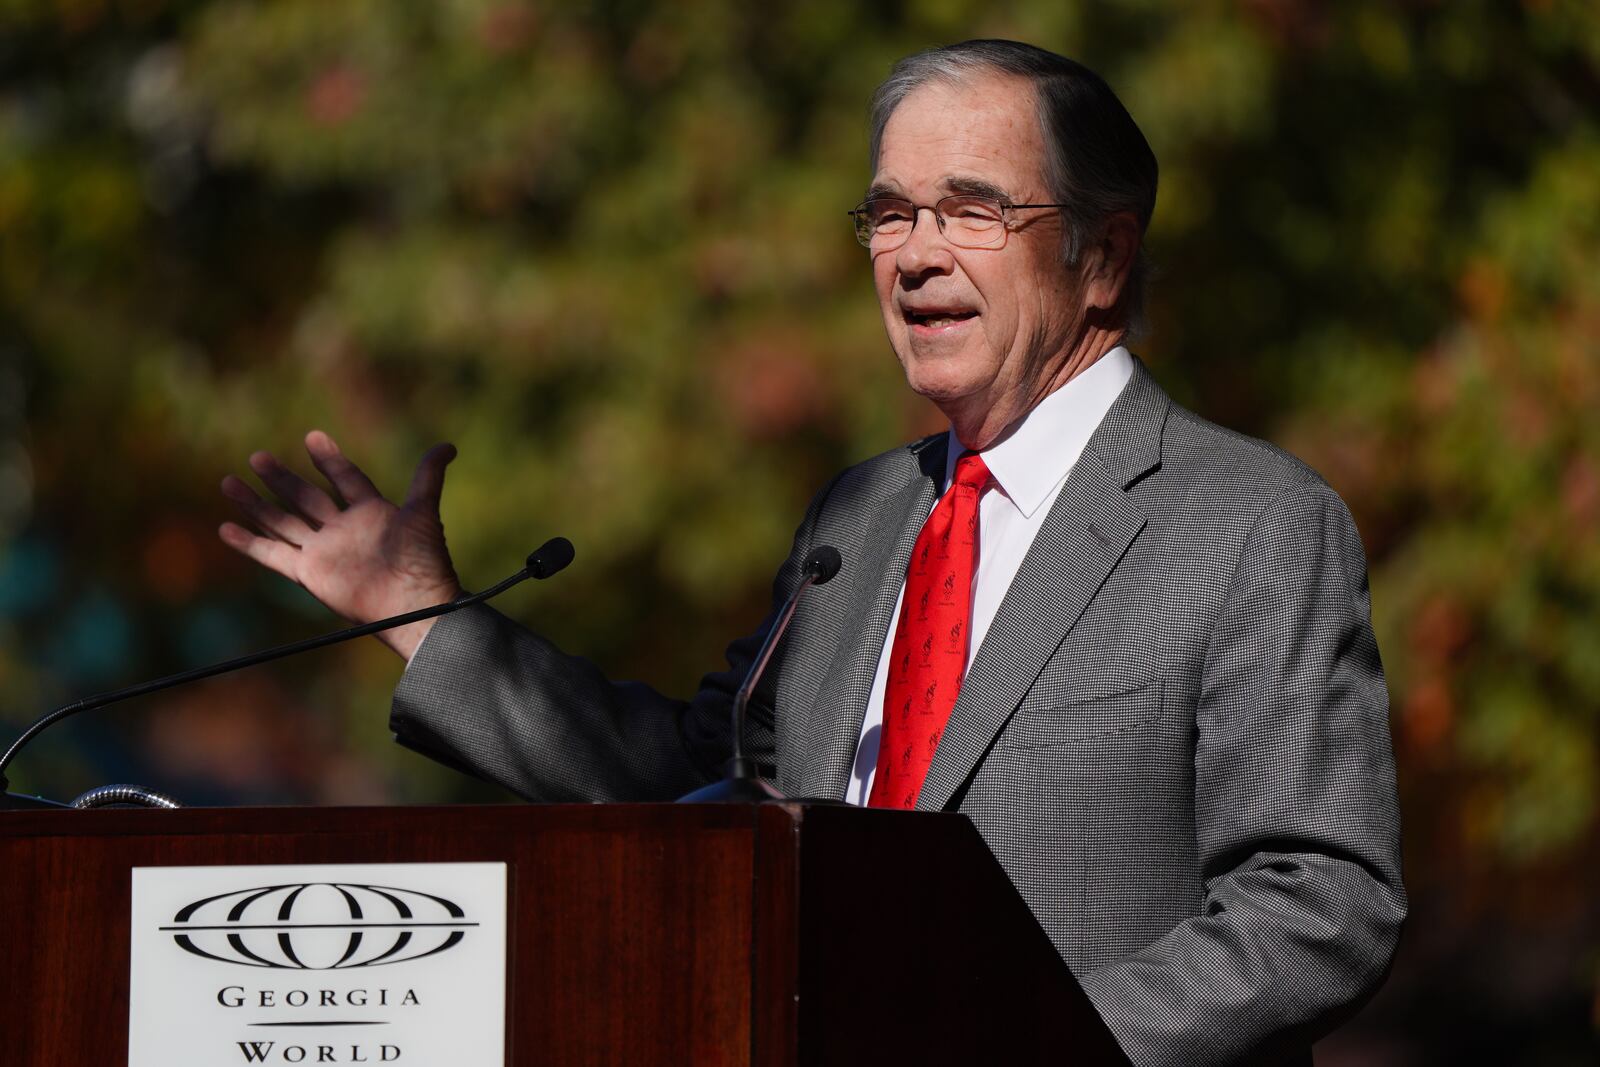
[{"left": 790, "top": 434, "right": 949, "bottom": 798}]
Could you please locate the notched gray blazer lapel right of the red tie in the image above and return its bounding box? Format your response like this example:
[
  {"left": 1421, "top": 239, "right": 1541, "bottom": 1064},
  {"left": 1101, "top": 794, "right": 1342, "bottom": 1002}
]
[{"left": 921, "top": 362, "right": 1171, "bottom": 811}]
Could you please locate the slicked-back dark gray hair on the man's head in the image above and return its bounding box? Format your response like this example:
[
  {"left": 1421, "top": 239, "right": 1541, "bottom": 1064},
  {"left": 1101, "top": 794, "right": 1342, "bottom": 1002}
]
[{"left": 870, "top": 40, "right": 1157, "bottom": 334}]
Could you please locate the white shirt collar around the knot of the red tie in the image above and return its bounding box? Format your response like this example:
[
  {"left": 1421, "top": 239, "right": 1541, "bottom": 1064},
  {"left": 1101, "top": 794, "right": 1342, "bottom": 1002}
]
[{"left": 944, "top": 346, "right": 1133, "bottom": 518}]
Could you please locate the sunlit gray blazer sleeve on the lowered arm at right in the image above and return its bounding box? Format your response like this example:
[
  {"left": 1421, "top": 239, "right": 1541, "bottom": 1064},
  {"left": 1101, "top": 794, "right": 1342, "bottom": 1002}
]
[{"left": 1080, "top": 482, "right": 1406, "bottom": 1064}]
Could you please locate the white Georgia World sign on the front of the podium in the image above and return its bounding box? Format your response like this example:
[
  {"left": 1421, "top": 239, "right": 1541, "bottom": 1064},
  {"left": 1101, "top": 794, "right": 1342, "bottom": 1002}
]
[{"left": 128, "top": 864, "right": 506, "bottom": 1067}]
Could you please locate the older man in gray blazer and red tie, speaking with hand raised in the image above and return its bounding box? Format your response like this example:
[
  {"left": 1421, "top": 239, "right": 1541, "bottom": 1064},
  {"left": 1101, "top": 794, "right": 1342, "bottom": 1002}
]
[{"left": 221, "top": 42, "right": 1406, "bottom": 1064}]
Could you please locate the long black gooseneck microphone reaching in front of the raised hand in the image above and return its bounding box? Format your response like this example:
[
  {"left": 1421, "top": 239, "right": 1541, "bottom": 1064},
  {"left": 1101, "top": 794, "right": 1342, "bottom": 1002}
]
[{"left": 0, "top": 537, "right": 573, "bottom": 809}]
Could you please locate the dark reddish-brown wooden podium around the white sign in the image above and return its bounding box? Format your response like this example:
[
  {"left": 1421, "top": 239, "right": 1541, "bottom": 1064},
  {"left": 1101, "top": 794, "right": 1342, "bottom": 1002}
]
[{"left": 0, "top": 803, "right": 1125, "bottom": 1067}]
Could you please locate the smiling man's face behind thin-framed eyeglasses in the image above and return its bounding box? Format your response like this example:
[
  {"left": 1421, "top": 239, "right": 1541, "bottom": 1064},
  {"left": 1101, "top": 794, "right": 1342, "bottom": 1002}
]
[{"left": 869, "top": 77, "right": 1082, "bottom": 435}]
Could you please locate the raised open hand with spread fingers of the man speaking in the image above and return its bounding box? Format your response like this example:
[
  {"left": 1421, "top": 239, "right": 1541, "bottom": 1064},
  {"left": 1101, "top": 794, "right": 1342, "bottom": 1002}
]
[{"left": 218, "top": 430, "right": 461, "bottom": 659}]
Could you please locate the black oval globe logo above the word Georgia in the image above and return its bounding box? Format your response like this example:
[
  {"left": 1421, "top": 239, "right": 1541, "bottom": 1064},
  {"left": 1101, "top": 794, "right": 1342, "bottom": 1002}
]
[{"left": 160, "top": 881, "right": 477, "bottom": 971}]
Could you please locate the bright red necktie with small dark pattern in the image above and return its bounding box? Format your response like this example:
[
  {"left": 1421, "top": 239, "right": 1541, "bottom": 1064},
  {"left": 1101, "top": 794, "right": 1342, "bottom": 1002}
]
[{"left": 867, "top": 453, "right": 992, "bottom": 808}]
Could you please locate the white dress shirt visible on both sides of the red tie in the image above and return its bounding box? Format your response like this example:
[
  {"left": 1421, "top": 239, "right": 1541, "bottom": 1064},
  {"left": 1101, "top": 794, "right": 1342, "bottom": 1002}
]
[{"left": 845, "top": 347, "right": 1133, "bottom": 805}]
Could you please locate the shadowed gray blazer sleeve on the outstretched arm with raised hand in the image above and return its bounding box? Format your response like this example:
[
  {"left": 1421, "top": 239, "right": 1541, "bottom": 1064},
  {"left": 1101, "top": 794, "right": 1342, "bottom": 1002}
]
[{"left": 389, "top": 490, "right": 827, "bottom": 801}]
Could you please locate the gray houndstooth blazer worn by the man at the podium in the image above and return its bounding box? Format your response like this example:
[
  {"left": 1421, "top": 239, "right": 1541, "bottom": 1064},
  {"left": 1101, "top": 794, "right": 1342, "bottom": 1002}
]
[{"left": 390, "top": 365, "right": 1406, "bottom": 1064}]
